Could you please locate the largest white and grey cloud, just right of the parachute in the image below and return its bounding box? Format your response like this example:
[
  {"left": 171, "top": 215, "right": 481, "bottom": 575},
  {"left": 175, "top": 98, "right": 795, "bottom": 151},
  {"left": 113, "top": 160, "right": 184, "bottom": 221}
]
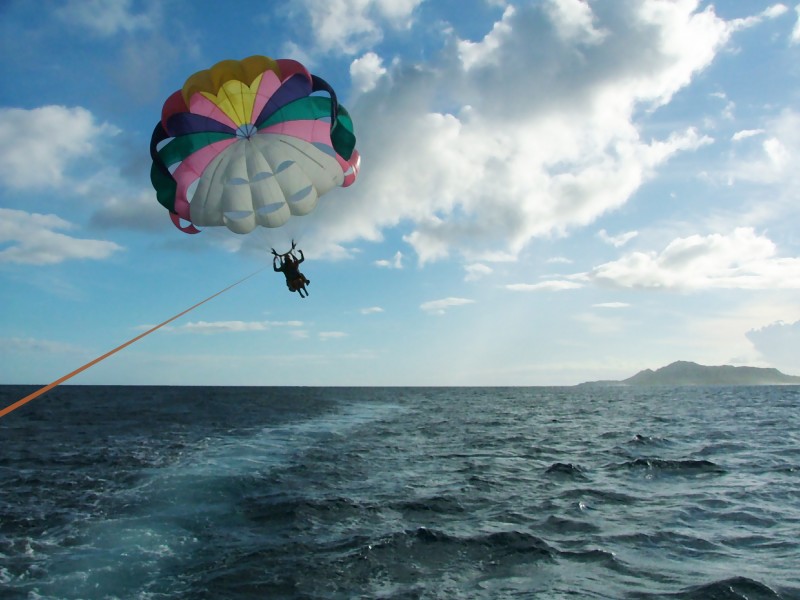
[{"left": 317, "top": 0, "right": 732, "bottom": 263}]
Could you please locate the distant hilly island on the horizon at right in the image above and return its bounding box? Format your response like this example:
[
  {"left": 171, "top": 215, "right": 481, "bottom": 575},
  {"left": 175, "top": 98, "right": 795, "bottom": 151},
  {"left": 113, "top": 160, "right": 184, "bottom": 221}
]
[{"left": 579, "top": 360, "right": 800, "bottom": 386}]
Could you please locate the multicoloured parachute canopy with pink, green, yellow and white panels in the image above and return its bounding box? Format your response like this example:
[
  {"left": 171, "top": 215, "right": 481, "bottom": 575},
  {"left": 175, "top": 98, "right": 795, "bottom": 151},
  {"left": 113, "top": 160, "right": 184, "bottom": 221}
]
[{"left": 150, "top": 56, "right": 360, "bottom": 233}]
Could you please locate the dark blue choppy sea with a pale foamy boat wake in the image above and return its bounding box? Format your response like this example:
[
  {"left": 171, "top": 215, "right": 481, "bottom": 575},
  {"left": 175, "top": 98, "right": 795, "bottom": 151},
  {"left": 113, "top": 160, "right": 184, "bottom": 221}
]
[{"left": 0, "top": 386, "right": 800, "bottom": 600}]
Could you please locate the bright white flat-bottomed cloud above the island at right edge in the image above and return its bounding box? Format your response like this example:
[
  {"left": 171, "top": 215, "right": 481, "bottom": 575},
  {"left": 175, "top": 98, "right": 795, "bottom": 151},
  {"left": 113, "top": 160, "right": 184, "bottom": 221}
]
[{"left": 588, "top": 227, "right": 800, "bottom": 290}]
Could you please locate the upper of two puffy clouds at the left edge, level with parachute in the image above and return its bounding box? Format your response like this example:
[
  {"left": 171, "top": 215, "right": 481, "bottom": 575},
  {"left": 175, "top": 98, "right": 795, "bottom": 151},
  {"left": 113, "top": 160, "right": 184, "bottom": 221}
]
[{"left": 0, "top": 106, "right": 118, "bottom": 189}]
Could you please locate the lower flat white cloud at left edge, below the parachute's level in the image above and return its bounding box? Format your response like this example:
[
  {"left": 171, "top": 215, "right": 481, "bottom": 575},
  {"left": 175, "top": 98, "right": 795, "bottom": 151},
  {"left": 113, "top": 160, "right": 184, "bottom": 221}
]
[{"left": 0, "top": 208, "right": 122, "bottom": 265}]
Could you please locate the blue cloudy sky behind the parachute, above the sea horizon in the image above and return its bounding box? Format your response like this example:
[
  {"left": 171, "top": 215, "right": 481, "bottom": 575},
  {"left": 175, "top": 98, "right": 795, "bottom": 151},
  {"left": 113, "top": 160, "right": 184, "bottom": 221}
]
[{"left": 0, "top": 0, "right": 800, "bottom": 386}]
